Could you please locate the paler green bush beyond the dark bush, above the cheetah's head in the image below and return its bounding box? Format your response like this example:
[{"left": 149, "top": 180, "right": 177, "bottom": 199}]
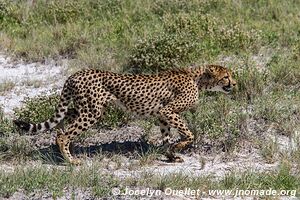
[{"left": 164, "top": 13, "right": 261, "bottom": 50}]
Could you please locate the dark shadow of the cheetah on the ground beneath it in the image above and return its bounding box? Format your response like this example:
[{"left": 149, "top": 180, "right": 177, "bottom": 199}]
[{"left": 38, "top": 141, "right": 155, "bottom": 165}]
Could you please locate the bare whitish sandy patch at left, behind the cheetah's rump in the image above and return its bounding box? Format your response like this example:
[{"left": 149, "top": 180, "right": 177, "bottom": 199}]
[{"left": 0, "top": 54, "right": 67, "bottom": 116}]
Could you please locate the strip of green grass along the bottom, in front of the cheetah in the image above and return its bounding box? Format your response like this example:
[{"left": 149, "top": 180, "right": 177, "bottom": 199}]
[{"left": 0, "top": 163, "right": 300, "bottom": 197}]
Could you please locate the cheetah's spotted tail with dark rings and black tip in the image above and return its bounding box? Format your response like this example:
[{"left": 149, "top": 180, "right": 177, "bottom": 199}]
[{"left": 13, "top": 84, "right": 71, "bottom": 133}]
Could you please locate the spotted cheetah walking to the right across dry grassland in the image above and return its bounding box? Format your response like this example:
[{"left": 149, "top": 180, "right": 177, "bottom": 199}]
[{"left": 14, "top": 65, "right": 236, "bottom": 164}]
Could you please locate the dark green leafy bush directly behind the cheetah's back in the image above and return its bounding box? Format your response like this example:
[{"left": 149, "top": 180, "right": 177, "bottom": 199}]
[{"left": 129, "top": 33, "right": 196, "bottom": 72}]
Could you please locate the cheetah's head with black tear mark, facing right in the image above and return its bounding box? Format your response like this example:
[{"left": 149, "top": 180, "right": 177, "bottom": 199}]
[{"left": 204, "top": 65, "right": 236, "bottom": 94}]
